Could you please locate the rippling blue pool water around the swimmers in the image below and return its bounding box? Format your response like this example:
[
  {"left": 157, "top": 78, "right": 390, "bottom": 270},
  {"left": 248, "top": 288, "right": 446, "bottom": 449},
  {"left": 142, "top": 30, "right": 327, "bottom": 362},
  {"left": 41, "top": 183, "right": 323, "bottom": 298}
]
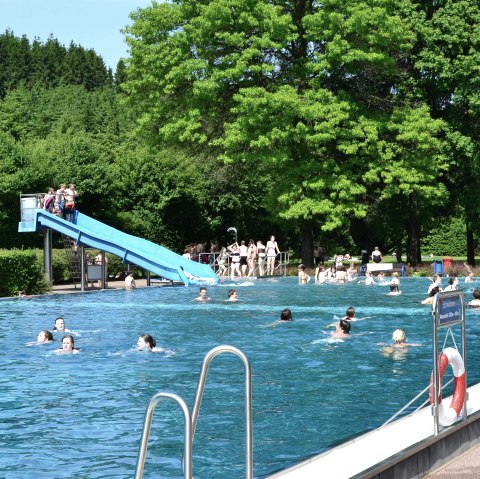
[{"left": 0, "top": 278, "right": 480, "bottom": 479}]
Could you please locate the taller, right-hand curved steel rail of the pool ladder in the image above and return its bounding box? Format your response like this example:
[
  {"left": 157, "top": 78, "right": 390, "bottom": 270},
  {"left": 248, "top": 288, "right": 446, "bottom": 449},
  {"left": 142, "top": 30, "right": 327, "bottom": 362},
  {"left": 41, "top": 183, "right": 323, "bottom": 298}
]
[{"left": 192, "top": 345, "right": 253, "bottom": 479}]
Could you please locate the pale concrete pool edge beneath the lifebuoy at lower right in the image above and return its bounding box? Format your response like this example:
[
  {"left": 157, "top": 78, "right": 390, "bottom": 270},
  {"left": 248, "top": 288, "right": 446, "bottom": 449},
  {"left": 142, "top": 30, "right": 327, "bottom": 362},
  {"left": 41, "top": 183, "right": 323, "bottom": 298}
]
[{"left": 266, "top": 384, "right": 480, "bottom": 479}]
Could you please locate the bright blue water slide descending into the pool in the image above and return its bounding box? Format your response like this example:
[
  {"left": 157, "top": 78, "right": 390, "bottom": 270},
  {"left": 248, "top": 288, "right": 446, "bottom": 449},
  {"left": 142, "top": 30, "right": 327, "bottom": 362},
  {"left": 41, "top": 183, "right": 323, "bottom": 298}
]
[{"left": 18, "top": 209, "right": 219, "bottom": 286}]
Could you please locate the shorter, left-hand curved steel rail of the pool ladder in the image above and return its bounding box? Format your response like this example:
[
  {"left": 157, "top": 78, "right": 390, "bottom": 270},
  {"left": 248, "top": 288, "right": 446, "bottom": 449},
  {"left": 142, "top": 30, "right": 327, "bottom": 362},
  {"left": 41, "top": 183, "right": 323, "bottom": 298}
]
[{"left": 135, "top": 392, "right": 193, "bottom": 479}]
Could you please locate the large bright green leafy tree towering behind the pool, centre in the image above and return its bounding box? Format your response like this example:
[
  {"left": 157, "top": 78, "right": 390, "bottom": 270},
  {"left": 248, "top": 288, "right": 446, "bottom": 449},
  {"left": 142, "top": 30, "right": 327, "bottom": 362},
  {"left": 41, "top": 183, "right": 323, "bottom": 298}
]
[{"left": 124, "top": 0, "right": 446, "bottom": 265}]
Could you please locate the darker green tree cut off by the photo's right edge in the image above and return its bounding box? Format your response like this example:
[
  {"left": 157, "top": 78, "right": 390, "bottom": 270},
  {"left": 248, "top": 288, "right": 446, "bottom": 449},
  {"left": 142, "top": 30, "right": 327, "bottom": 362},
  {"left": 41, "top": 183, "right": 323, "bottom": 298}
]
[{"left": 409, "top": 0, "right": 480, "bottom": 264}]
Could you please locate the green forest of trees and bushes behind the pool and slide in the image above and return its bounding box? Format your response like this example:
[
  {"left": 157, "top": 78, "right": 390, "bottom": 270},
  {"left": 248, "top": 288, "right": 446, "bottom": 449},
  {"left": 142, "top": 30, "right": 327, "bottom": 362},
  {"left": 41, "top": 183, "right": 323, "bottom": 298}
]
[{"left": 0, "top": 0, "right": 480, "bottom": 266}]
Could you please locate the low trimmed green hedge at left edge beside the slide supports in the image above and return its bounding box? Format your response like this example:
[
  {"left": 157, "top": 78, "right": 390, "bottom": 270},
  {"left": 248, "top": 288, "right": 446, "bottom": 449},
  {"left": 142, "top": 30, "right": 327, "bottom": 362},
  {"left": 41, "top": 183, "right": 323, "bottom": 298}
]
[{"left": 0, "top": 250, "right": 50, "bottom": 297}]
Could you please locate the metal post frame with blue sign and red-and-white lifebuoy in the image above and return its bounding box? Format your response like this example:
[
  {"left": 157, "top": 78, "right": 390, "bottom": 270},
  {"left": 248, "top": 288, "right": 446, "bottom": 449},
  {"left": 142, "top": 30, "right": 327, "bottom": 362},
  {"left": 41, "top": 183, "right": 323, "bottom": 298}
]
[{"left": 430, "top": 291, "right": 467, "bottom": 435}]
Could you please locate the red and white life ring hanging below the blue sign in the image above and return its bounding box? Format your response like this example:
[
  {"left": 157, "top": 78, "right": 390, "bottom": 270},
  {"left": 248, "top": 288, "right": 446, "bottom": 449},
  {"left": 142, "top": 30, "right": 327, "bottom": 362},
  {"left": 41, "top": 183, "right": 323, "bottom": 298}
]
[{"left": 430, "top": 348, "right": 466, "bottom": 426}]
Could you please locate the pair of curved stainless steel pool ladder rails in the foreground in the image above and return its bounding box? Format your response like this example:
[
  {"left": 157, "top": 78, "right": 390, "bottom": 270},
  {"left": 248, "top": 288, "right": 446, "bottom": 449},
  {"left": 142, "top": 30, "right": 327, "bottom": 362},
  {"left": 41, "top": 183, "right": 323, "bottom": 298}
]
[{"left": 135, "top": 345, "right": 253, "bottom": 479}]
